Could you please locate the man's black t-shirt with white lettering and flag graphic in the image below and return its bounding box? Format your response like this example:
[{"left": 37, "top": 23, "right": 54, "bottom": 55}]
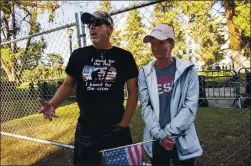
[{"left": 65, "top": 46, "right": 138, "bottom": 135}]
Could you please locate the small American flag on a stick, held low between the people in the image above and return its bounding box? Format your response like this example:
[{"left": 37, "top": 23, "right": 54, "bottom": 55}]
[{"left": 104, "top": 144, "right": 143, "bottom": 166}]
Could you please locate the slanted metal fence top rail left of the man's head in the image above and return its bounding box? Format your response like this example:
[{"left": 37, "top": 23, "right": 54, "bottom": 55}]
[{"left": 0, "top": 23, "right": 76, "bottom": 46}]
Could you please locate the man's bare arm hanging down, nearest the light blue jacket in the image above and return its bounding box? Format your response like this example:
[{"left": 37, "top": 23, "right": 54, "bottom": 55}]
[{"left": 119, "top": 78, "right": 138, "bottom": 127}]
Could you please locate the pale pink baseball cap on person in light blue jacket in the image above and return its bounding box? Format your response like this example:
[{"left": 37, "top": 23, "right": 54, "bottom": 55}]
[{"left": 143, "top": 24, "right": 174, "bottom": 43}]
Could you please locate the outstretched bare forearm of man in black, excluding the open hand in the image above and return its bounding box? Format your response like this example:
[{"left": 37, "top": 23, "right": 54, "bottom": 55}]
[{"left": 49, "top": 75, "right": 75, "bottom": 109}]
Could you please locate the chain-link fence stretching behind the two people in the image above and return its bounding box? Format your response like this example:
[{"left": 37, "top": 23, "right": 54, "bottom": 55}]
[{"left": 0, "top": 1, "right": 251, "bottom": 165}]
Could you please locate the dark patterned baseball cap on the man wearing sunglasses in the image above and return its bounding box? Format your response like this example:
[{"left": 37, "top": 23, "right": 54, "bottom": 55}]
[{"left": 81, "top": 11, "right": 113, "bottom": 25}]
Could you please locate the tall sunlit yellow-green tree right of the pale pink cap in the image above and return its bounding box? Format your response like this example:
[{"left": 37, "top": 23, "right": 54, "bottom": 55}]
[{"left": 182, "top": 1, "right": 226, "bottom": 68}]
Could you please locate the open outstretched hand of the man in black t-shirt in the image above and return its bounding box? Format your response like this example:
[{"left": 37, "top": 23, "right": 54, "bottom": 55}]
[{"left": 38, "top": 98, "right": 59, "bottom": 120}]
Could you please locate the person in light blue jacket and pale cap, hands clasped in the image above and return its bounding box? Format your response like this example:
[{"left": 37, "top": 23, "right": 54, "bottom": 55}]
[{"left": 138, "top": 24, "right": 202, "bottom": 165}]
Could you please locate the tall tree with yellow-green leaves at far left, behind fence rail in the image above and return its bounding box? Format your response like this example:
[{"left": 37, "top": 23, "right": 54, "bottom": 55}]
[{"left": 0, "top": 0, "right": 59, "bottom": 82}]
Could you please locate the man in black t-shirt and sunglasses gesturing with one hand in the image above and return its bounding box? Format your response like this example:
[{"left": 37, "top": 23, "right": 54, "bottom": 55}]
[{"left": 40, "top": 11, "right": 138, "bottom": 165}]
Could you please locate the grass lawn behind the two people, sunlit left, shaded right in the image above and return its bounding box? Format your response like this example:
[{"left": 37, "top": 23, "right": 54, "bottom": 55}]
[{"left": 1, "top": 103, "right": 250, "bottom": 165}]
